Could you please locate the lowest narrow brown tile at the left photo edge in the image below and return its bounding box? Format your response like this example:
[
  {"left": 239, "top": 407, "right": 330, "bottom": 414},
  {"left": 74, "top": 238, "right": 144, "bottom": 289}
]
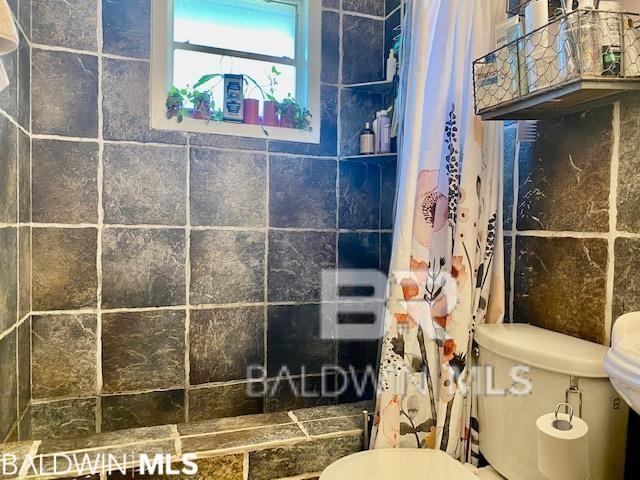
[{"left": 0, "top": 330, "right": 18, "bottom": 443}]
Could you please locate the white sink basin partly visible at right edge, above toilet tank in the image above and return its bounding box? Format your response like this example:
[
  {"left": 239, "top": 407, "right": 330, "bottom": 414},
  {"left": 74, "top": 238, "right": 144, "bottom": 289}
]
[{"left": 604, "top": 312, "right": 640, "bottom": 413}]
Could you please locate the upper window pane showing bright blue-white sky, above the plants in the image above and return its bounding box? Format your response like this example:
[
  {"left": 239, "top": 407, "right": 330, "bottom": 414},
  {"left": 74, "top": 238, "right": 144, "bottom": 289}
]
[{"left": 173, "top": 0, "right": 296, "bottom": 58}]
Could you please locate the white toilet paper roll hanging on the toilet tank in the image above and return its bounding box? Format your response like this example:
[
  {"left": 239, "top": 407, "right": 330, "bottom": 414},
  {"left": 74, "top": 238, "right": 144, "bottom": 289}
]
[{"left": 536, "top": 413, "right": 590, "bottom": 480}]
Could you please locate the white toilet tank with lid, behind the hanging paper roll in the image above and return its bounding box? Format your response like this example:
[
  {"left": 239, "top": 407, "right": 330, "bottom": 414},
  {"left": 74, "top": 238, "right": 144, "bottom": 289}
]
[{"left": 476, "top": 324, "right": 629, "bottom": 480}]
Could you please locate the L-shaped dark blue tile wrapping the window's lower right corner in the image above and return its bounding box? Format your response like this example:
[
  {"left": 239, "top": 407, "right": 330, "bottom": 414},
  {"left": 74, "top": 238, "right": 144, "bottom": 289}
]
[{"left": 269, "top": 85, "right": 338, "bottom": 157}]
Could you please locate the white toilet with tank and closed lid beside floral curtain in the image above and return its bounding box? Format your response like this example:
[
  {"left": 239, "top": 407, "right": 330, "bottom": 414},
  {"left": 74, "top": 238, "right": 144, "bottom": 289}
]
[{"left": 320, "top": 324, "right": 629, "bottom": 480}]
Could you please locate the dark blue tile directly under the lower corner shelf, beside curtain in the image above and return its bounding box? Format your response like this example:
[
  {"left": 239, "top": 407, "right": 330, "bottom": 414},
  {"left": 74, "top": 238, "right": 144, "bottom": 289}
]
[{"left": 338, "top": 161, "right": 380, "bottom": 229}]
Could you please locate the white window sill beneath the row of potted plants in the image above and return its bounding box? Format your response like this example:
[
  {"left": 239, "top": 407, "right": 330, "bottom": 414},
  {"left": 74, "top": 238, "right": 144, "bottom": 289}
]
[{"left": 151, "top": 117, "right": 320, "bottom": 143}]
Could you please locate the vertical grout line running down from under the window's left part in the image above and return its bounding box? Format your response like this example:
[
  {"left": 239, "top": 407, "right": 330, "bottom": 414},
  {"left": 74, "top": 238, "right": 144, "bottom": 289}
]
[{"left": 184, "top": 135, "right": 191, "bottom": 422}]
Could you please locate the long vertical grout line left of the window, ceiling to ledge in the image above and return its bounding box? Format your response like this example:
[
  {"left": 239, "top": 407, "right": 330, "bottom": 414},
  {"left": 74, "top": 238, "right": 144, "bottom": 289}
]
[{"left": 96, "top": 0, "right": 104, "bottom": 433}]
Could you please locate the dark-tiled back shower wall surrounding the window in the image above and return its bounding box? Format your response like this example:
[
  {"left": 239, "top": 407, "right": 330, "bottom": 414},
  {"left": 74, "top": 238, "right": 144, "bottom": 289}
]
[{"left": 7, "top": 0, "right": 397, "bottom": 438}]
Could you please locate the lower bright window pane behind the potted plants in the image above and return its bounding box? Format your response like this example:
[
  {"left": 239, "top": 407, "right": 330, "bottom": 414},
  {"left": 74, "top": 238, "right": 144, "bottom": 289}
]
[{"left": 173, "top": 50, "right": 296, "bottom": 107}]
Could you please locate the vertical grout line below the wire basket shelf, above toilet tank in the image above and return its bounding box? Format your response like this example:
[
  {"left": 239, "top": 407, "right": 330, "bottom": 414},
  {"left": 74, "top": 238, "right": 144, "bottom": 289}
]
[{"left": 604, "top": 101, "right": 621, "bottom": 345}]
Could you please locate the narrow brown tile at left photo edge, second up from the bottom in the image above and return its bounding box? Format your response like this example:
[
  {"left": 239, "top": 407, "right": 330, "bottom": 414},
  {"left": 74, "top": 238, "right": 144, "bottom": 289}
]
[{"left": 0, "top": 228, "right": 18, "bottom": 334}]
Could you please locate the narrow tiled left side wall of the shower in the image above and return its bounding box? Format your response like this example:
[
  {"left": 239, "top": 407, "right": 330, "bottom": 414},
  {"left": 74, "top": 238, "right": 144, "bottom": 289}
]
[{"left": 0, "top": 0, "right": 31, "bottom": 442}]
